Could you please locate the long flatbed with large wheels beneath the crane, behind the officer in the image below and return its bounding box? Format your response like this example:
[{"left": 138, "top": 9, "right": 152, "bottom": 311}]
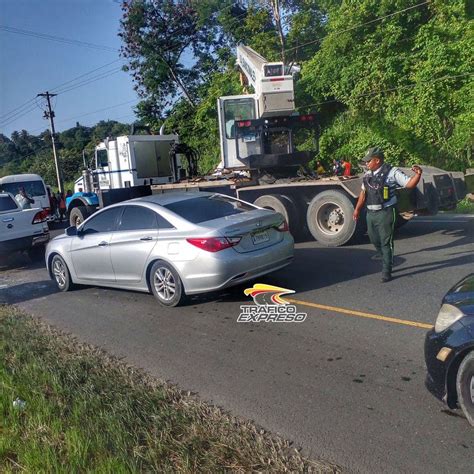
[{"left": 151, "top": 167, "right": 465, "bottom": 247}]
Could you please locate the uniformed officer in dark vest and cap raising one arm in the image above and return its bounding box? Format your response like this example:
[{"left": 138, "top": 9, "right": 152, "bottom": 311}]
[{"left": 353, "top": 147, "right": 423, "bottom": 283}]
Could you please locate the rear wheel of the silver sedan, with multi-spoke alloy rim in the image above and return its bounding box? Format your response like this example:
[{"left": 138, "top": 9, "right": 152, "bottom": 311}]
[{"left": 150, "top": 261, "right": 185, "bottom": 306}]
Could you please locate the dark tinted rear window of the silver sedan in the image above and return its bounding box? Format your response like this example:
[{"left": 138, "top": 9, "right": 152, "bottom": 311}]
[{"left": 165, "top": 195, "right": 255, "bottom": 224}]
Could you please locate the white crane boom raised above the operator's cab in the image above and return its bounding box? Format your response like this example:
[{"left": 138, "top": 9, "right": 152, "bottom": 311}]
[{"left": 237, "top": 44, "right": 295, "bottom": 118}]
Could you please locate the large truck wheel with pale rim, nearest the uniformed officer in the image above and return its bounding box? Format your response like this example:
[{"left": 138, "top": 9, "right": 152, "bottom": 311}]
[{"left": 306, "top": 190, "right": 363, "bottom": 247}]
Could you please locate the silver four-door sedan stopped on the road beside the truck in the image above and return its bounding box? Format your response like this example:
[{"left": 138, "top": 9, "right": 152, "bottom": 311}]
[{"left": 46, "top": 192, "right": 294, "bottom": 306}]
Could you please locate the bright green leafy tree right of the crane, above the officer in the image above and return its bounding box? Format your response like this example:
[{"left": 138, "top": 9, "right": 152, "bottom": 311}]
[{"left": 303, "top": 0, "right": 474, "bottom": 169}]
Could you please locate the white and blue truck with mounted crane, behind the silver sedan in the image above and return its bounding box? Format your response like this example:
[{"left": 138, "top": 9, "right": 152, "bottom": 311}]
[{"left": 67, "top": 45, "right": 467, "bottom": 247}]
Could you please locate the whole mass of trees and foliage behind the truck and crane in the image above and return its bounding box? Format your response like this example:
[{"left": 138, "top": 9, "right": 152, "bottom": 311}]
[{"left": 0, "top": 0, "right": 474, "bottom": 182}]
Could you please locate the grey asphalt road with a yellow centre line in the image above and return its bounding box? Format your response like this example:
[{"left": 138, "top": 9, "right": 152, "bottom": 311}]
[{"left": 0, "top": 215, "right": 474, "bottom": 473}]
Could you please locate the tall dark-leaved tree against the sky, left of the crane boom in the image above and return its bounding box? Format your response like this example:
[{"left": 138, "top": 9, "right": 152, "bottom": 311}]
[{"left": 119, "top": 0, "right": 223, "bottom": 114}]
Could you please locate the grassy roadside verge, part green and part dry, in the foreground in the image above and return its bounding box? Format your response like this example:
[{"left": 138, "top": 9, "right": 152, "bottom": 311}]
[{"left": 0, "top": 306, "right": 337, "bottom": 473}]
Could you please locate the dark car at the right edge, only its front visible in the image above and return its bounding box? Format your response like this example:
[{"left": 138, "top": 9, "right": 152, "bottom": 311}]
[{"left": 425, "top": 273, "right": 474, "bottom": 426}]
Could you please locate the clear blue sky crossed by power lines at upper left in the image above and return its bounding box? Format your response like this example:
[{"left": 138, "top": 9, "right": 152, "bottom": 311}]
[{"left": 0, "top": 0, "right": 138, "bottom": 136}]
